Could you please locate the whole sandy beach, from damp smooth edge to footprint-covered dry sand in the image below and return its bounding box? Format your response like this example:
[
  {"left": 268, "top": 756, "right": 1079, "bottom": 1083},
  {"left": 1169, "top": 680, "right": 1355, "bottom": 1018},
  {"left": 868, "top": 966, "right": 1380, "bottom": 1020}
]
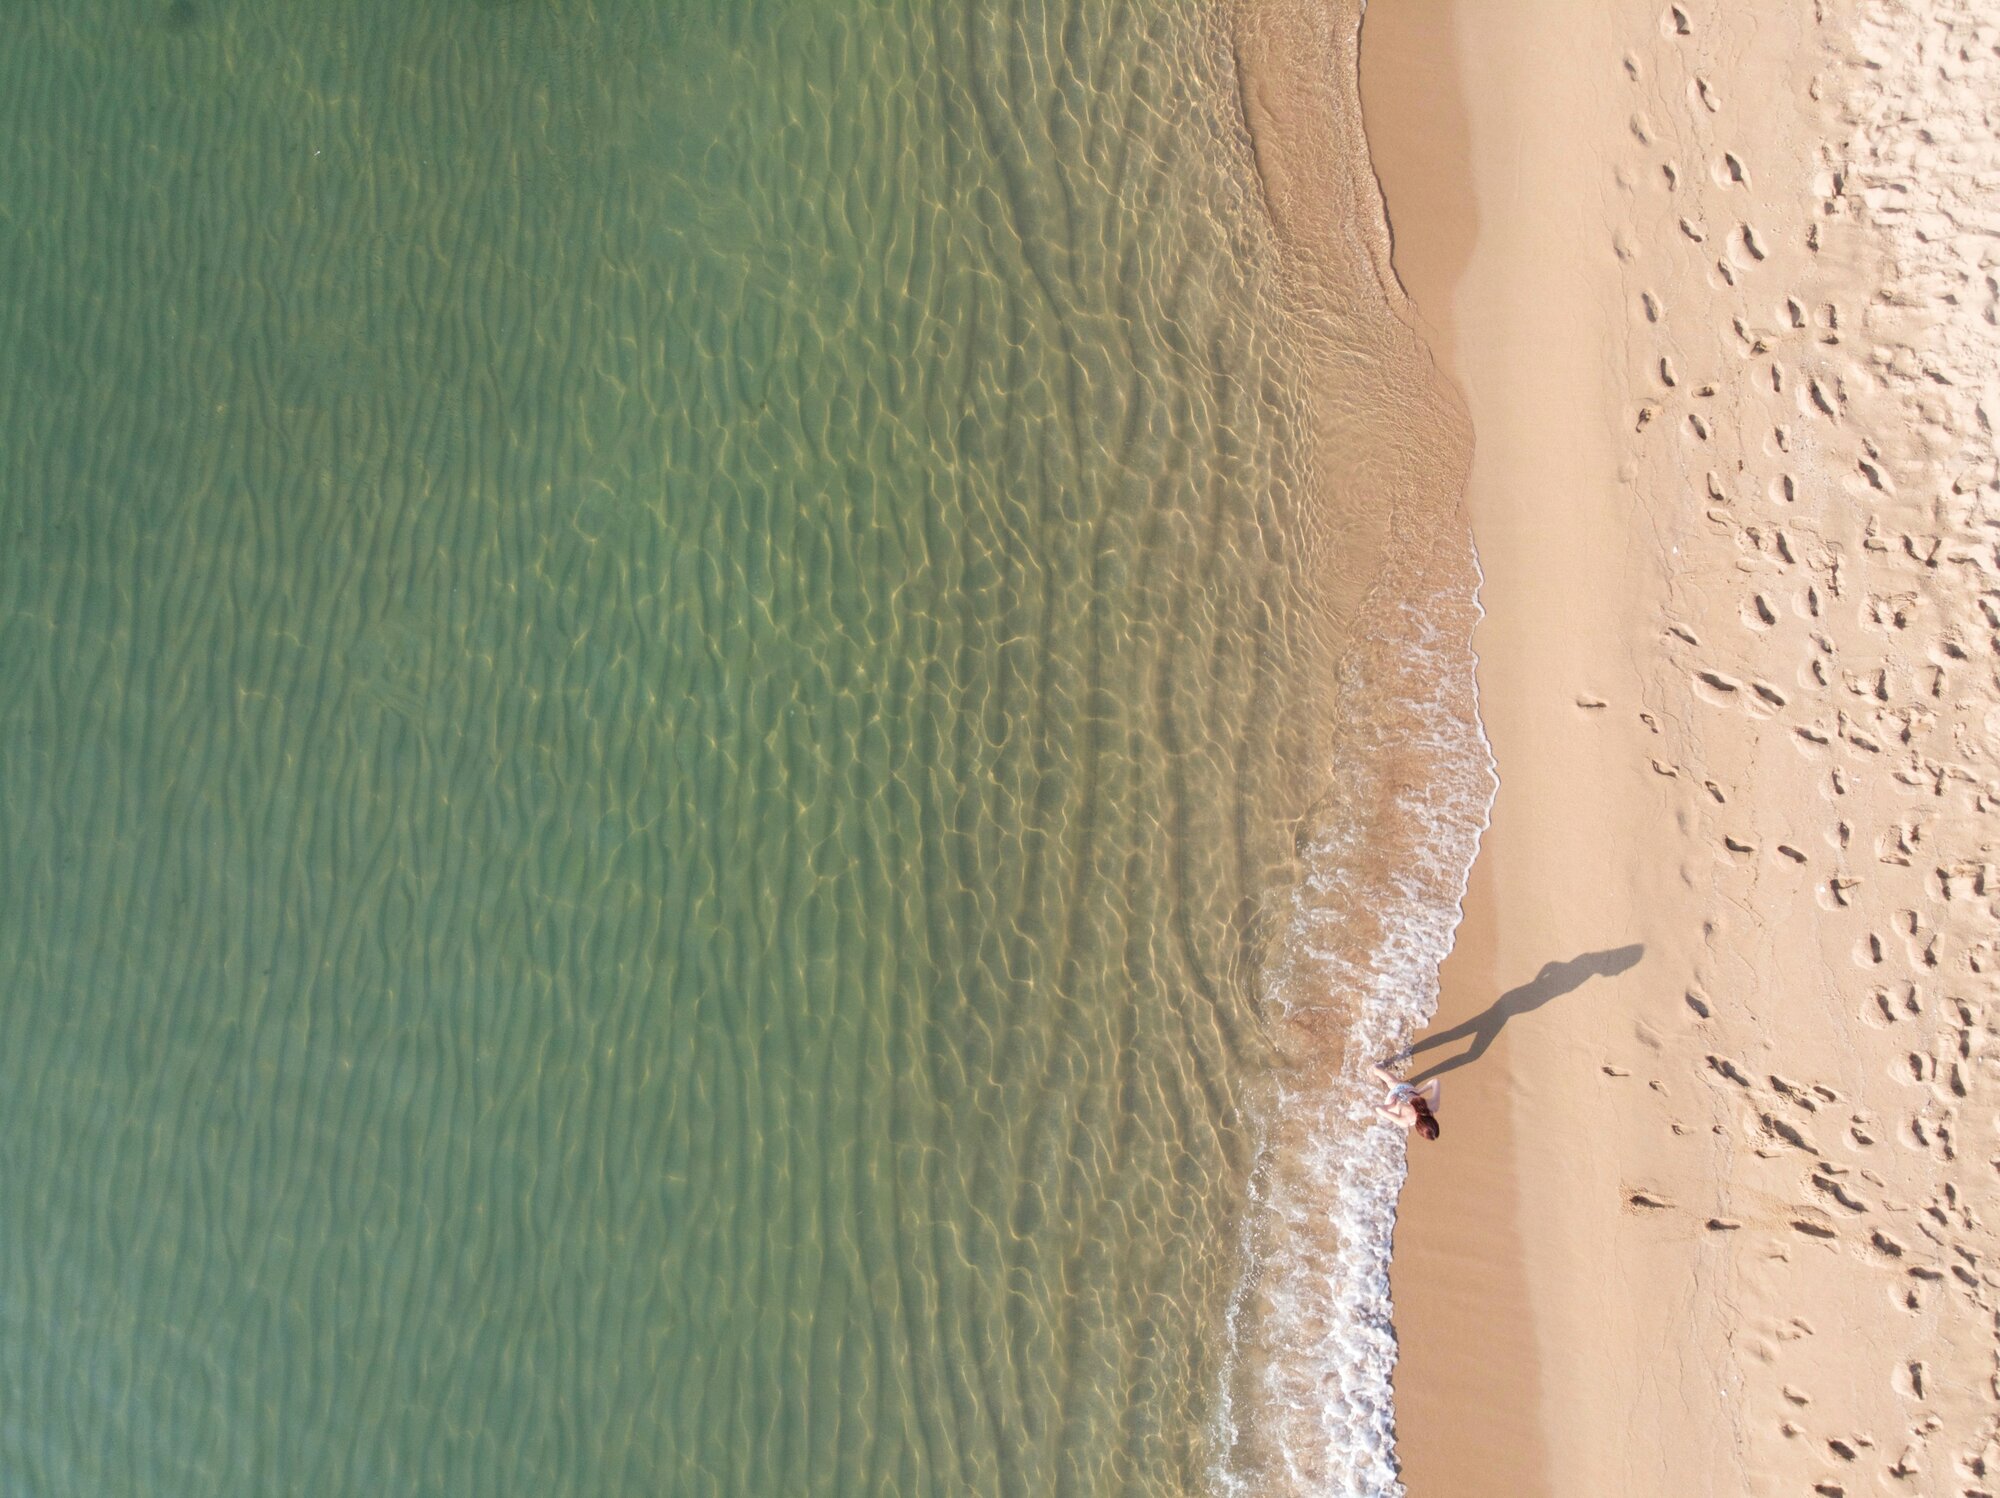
[{"left": 1362, "top": 0, "right": 2000, "bottom": 1498}]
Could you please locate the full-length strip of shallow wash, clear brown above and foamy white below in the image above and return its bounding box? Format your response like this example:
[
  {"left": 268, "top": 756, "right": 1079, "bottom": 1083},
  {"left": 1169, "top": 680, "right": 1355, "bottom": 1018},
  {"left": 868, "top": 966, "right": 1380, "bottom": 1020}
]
[{"left": 1218, "top": 0, "right": 1492, "bottom": 1492}]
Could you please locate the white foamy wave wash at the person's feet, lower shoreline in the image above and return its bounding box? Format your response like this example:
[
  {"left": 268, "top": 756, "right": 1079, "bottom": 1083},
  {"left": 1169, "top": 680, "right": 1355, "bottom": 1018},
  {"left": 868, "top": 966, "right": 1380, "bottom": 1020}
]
[{"left": 1216, "top": 548, "right": 1496, "bottom": 1498}]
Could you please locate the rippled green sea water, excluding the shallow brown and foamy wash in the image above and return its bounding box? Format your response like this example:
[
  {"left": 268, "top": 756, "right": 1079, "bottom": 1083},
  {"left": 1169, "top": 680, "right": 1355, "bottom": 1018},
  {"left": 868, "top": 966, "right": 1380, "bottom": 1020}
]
[{"left": 0, "top": 0, "right": 1352, "bottom": 1498}]
